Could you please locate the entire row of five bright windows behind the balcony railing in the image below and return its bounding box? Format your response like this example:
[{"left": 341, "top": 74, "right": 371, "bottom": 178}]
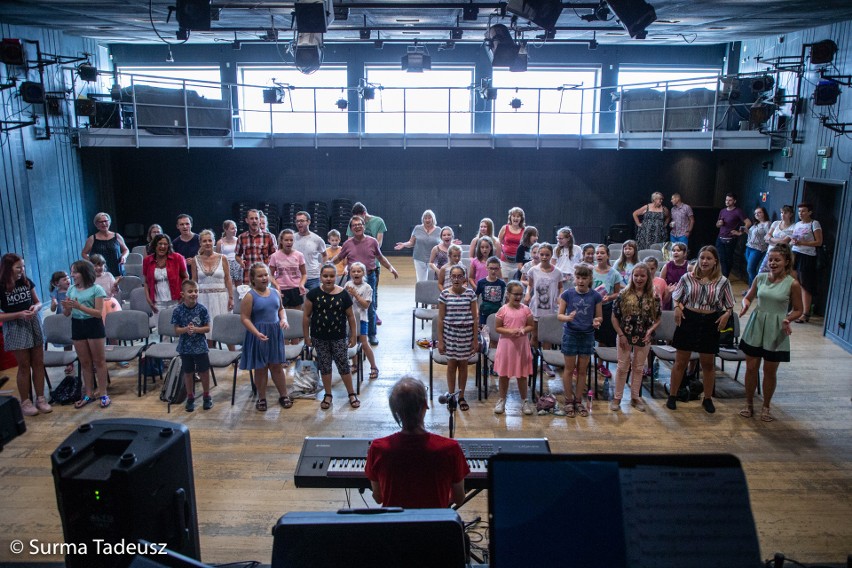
[{"left": 113, "top": 65, "right": 720, "bottom": 134}]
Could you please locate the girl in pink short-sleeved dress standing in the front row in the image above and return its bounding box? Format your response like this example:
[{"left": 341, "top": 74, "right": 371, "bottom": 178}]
[{"left": 494, "top": 280, "right": 533, "bottom": 415}]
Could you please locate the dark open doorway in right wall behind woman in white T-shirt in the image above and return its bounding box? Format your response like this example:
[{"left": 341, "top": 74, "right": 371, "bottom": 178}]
[{"left": 797, "top": 179, "right": 846, "bottom": 316}]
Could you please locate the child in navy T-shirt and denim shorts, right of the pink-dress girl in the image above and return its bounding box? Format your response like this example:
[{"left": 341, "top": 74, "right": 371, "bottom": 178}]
[{"left": 556, "top": 264, "right": 603, "bottom": 417}]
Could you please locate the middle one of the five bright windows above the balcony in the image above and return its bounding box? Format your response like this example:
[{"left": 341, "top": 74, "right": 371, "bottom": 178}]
[{"left": 363, "top": 65, "right": 473, "bottom": 134}]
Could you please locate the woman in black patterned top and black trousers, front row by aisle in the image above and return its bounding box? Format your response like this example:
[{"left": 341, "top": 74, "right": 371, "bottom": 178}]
[{"left": 302, "top": 263, "right": 361, "bottom": 410}]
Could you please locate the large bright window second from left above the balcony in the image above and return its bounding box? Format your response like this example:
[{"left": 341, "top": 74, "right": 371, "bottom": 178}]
[{"left": 239, "top": 66, "right": 349, "bottom": 133}]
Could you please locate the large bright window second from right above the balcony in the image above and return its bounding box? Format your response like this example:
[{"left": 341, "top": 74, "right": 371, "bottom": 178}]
[{"left": 492, "top": 68, "right": 599, "bottom": 134}]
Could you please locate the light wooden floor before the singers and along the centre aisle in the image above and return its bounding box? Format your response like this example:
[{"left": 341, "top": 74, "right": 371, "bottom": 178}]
[{"left": 0, "top": 259, "right": 852, "bottom": 563}]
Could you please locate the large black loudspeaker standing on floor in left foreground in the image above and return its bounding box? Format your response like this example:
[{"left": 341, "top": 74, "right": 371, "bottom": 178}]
[{"left": 51, "top": 418, "right": 201, "bottom": 568}]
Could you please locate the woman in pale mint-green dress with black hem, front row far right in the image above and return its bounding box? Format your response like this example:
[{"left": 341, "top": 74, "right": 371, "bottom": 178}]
[{"left": 740, "top": 244, "right": 802, "bottom": 422}]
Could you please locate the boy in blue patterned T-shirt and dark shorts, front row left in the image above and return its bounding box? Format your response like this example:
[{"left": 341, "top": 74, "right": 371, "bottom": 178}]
[{"left": 172, "top": 280, "right": 213, "bottom": 412}]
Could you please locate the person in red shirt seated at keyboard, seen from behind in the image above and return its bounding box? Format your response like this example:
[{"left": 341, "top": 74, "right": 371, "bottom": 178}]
[{"left": 366, "top": 377, "right": 470, "bottom": 509}]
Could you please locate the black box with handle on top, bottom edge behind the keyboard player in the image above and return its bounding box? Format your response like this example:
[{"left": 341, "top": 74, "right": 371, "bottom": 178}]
[{"left": 272, "top": 508, "right": 465, "bottom": 568}]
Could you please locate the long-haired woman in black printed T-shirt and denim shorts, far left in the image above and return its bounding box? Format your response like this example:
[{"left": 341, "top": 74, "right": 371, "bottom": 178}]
[{"left": 0, "top": 253, "right": 52, "bottom": 416}]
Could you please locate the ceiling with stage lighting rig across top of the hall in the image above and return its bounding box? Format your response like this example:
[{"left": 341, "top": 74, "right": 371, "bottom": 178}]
[{"left": 0, "top": 0, "right": 852, "bottom": 46}]
